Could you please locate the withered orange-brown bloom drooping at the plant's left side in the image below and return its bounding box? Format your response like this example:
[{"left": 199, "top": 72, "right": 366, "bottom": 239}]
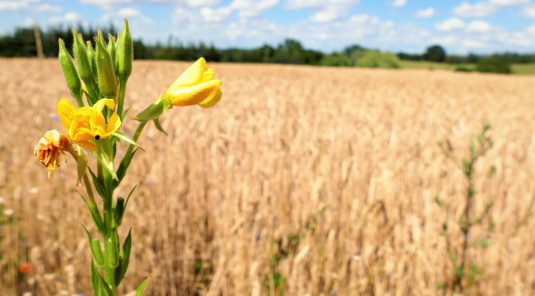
[{"left": 34, "top": 129, "right": 69, "bottom": 176}]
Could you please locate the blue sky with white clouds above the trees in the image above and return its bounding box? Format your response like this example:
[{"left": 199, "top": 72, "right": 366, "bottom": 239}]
[{"left": 0, "top": 0, "right": 535, "bottom": 53}]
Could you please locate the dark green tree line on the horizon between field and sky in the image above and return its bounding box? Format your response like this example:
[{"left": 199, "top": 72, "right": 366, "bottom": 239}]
[{"left": 0, "top": 25, "right": 535, "bottom": 66}]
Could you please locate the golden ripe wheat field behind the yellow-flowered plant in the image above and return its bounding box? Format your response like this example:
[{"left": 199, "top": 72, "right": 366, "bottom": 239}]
[{"left": 0, "top": 59, "right": 535, "bottom": 295}]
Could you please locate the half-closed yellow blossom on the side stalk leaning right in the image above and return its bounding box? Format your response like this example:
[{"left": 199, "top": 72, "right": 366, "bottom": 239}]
[{"left": 162, "top": 58, "right": 222, "bottom": 108}]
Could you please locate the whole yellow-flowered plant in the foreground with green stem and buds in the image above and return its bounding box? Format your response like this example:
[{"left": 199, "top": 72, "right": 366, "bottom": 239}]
[{"left": 34, "top": 20, "right": 222, "bottom": 296}]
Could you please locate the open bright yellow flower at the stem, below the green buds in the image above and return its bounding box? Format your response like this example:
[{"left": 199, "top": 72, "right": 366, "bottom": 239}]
[{"left": 57, "top": 99, "right": 121, "bottom": 151}]
